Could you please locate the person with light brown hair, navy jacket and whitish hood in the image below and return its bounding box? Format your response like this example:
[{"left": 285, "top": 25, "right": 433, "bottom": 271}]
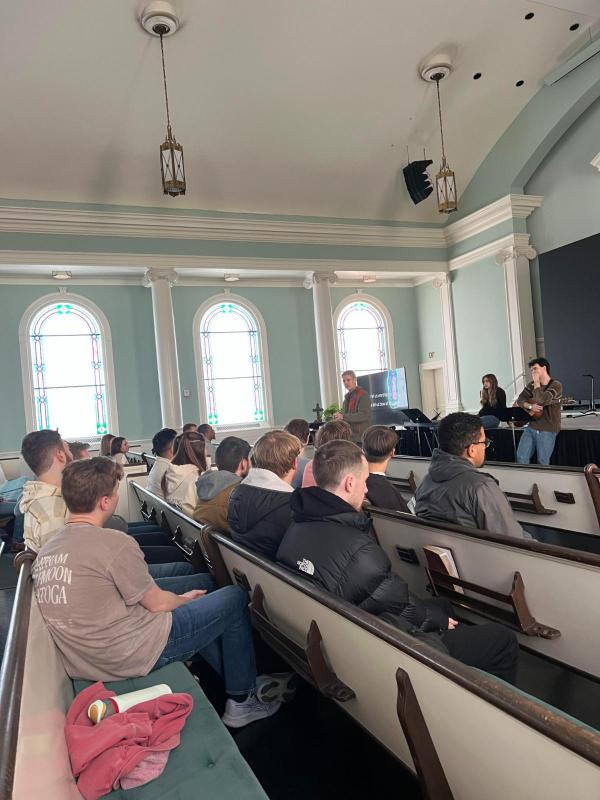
[{"left": 227, "top": 431, "right": 302, "bottom": 558}]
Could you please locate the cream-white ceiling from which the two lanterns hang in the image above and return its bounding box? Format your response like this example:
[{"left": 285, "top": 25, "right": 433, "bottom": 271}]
[{"left": 0, "top": 0, "right": 600, "bottom": 222}]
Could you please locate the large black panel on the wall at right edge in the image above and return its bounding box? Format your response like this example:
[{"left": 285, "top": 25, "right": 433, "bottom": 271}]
[{"left": 539, "top": 234, "right": 600, "bottom": 401}]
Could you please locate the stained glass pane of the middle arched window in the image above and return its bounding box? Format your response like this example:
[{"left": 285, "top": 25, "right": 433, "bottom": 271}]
[{"left": 200, "top": 301, "right": 267, "bottom": 426}]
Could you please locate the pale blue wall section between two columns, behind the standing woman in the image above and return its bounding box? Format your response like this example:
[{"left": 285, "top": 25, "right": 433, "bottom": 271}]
[{"left": 452, "top": 258, "right": 512, "bottom": 411}]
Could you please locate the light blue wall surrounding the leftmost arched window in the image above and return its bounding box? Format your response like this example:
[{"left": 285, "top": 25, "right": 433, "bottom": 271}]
[{"left": 0, "top": 285, "right": 161, "bottom": 451}]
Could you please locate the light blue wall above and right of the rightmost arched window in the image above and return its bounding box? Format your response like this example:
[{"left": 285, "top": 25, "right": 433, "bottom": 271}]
[{"left": 331, "top": 287, "right": 421, "bottom": 408}]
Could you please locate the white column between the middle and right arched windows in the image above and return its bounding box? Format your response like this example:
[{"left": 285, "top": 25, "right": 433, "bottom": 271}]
[{"left": 305, "top": 272, "right": 340, "bottom": 408}]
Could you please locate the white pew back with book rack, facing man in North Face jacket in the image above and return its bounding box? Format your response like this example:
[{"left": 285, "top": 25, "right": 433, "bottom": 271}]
[{"left": 370, "top": 508, "right": 600, "bottom": 677}]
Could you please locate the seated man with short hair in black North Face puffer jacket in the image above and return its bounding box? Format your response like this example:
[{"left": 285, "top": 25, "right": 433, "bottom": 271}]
[{"left": 277, "top": 441, "right": 518, "bottom": 682}]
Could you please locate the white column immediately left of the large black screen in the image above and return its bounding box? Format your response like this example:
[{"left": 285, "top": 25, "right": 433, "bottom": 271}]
[{"left": 496, "top": 245, "right": 537, "bottom": 401}]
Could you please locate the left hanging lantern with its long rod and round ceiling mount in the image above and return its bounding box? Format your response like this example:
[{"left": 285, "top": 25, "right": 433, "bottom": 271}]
[{"left": 141, "top": 0, "right": 186, "bottom": 197}]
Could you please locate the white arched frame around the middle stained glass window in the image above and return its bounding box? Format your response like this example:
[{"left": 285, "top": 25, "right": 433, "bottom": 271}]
[{"left": 192, "top": 293, "right": 273, "bottom": 431}]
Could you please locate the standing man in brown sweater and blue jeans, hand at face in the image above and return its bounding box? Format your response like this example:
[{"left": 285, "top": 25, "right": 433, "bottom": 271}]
[{"left": 516, "top": 358, "right": 562, "bottom": 464}]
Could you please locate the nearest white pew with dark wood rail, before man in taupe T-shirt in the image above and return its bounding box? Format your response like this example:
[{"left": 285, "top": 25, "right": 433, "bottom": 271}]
[{"left": 127, "top": 487, "right": 600, "bottom": 800}]
